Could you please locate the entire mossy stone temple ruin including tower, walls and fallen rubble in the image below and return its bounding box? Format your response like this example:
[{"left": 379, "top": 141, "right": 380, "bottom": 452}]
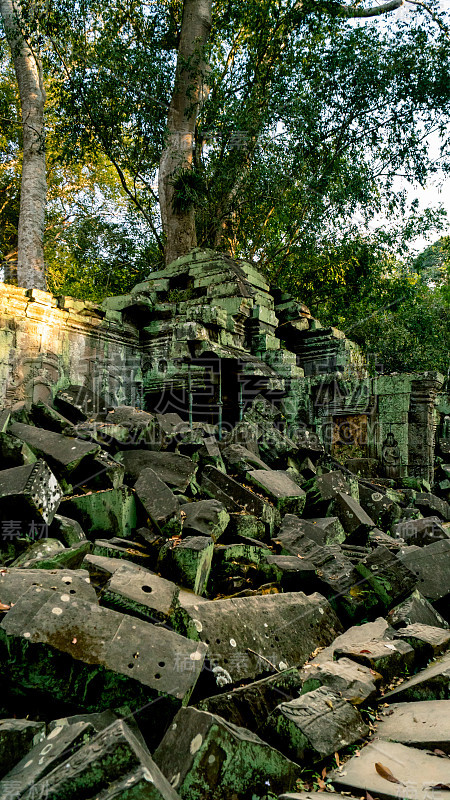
[{"left": 0, "top": 250, "right": 450, "bottom": 800}]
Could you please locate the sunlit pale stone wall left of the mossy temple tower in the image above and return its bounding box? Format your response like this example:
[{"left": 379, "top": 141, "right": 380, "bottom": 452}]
[{"left": 0, "top": 284, "right": 142, "bottom": 407}]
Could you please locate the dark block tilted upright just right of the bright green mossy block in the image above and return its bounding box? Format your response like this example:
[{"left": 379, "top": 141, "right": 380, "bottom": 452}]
[{"left": 134, "top": 467, "right": 181, "bottom": 535}]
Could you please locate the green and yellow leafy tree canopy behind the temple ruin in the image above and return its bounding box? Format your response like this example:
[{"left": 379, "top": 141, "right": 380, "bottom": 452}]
[{"left": 0, "top": 0, "right": 450, "bottom": 366}]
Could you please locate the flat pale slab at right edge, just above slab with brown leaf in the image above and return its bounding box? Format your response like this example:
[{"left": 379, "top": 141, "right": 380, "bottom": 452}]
[{"left": 377, "top": 700, "right": 450, "bottom": 752}]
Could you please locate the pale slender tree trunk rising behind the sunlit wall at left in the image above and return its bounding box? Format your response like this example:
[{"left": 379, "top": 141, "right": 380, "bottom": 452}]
[{"left": 0, "top": 0, "right": 47, "bottom": 289}]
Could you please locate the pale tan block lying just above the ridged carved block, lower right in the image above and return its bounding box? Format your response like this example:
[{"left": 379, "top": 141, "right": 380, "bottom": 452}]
[{"left": 301, "top": 658, "right": 381, "bottom": 705}]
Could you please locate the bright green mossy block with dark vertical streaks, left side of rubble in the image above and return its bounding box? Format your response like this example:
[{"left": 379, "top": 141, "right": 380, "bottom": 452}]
[{"left": 59, "top": 486, "right": 137, "bottom": 541}]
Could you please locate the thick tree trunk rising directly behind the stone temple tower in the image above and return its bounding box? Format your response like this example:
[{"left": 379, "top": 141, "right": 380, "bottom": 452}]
[{"left": 158, "top": 0, "right": 212, "bottom": 264}]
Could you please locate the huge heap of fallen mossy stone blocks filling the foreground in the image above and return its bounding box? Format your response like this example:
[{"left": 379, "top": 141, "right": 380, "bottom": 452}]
[{"left": 0, "top": 387, "right": 450, "bottom": 800}]
